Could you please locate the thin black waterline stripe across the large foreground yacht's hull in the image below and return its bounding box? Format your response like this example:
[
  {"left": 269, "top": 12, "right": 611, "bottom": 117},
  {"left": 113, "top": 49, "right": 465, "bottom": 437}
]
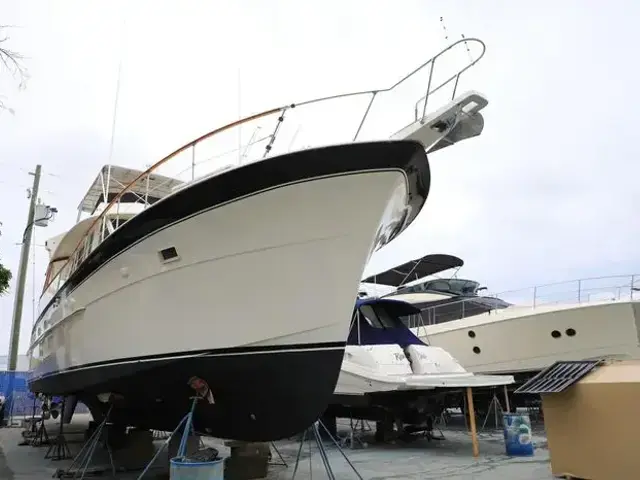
[{"left": 29, "top": 341, "right": 346, "bottom": 383}]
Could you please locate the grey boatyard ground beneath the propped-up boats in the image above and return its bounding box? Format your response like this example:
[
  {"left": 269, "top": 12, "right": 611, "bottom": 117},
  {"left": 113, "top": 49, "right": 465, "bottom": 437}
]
[{"left": 0, "top": 415, "right": 553, "bottom": 480}]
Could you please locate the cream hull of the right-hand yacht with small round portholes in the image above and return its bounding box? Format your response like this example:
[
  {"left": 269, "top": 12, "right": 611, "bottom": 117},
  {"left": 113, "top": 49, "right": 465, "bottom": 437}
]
[{"left": 412, "top": 301, "right": 640, "bottom": 374}]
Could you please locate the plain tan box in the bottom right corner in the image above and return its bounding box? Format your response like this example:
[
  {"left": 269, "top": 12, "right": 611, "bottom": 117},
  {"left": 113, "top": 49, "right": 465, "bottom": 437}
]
[{"left": 542, "top": 361, "right": 640, "bottom": 480}]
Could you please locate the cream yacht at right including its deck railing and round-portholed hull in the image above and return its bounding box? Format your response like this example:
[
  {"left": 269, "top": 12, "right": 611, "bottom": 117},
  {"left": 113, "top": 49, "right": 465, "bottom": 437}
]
[{"left": 412, "top": 275, "right": 640, "bottom": 376}]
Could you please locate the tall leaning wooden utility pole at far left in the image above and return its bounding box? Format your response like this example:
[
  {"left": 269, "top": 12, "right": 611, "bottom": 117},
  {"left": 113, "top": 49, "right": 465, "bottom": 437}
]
[{"left": 7, "top": 165, "right": 42, "bottom": 372}]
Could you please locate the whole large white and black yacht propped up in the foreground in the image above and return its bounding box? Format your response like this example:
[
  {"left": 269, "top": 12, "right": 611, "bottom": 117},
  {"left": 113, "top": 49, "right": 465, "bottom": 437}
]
[{"left": 29, "top": 39, "right": 487, "bottom": 441}]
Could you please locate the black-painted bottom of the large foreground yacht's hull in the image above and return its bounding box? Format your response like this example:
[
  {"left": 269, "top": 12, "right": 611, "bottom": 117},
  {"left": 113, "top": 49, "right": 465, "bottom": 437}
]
[{"left": 31, "top": 345, "right": 344, "bottom": 441}]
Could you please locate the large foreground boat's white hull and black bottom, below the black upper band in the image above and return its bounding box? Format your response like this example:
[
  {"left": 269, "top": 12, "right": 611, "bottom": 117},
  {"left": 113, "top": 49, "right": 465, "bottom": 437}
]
[{"left": 30, "top": 144, "right": 428, "bottom": 441}]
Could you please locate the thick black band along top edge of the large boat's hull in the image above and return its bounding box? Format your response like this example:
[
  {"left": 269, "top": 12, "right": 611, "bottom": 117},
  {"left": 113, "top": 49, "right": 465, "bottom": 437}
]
[{"left": 38, "top": 140, "right": 431, "bottom": 320}]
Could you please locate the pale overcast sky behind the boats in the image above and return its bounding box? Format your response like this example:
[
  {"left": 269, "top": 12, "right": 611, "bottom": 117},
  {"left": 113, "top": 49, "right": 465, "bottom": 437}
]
[{"left": 0, "top": 0, "right": 640, "bottom": 353}]
